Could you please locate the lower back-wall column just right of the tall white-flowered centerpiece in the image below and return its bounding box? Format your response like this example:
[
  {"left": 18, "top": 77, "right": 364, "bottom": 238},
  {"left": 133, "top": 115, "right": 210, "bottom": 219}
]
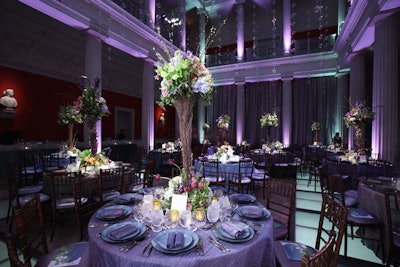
[{"left": 282, "top": 77, "right": 293, "bottom": 147}]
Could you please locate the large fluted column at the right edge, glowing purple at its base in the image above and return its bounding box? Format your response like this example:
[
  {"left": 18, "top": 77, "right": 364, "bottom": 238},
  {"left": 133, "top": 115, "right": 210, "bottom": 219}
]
[{"left": 372, "top": 15, "right": 400, "bottom": 162}]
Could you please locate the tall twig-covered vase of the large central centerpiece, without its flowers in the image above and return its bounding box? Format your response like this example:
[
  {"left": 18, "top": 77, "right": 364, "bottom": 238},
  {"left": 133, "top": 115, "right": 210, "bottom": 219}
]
[{"left": 174, "top": 96, "right": 195, "bottom": 179}]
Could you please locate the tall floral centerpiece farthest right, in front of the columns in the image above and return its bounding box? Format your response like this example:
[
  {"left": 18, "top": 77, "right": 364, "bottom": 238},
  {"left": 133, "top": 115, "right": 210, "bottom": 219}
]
[{"left": 343, "top": 103, "right": 375, "bottom": 151}]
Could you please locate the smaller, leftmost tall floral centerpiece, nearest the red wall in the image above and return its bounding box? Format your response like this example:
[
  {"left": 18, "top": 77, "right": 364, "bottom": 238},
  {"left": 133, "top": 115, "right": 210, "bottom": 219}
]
[{"left": 57, "top": 105, "right": 83, "bottom": 150}]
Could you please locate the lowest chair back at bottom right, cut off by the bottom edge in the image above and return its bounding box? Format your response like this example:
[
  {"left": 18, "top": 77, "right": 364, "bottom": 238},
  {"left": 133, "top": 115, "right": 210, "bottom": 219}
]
[{"left": 301, "top": 231, "right": 336, "bottom": 267}]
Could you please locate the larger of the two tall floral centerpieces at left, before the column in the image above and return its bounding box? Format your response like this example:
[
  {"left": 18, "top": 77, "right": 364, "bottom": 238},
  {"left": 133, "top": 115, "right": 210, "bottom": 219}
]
[{"left": 73, "top": 76, "right": 109, "bottom": 155}]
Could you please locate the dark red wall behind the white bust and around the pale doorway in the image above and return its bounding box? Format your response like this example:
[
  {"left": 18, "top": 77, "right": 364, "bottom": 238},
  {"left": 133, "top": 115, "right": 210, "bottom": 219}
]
[{"left": 0, "top": 66, "right": 147, "bottom": 141}]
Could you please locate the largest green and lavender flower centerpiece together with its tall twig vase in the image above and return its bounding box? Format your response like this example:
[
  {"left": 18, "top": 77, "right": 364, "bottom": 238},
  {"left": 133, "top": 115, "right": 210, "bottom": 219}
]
[{"left": 155, "top": 49, "right": 214, "bottom": 180}]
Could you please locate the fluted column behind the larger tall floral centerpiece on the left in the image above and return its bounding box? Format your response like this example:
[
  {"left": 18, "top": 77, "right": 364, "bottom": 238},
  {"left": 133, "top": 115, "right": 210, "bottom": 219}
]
[{"left": 83, "top": 34, "right": 101, "bottom": 152}]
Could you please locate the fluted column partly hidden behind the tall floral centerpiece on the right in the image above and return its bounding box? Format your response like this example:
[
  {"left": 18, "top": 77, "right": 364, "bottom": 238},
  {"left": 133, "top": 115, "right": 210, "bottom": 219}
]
[{"left": 348, "top": 53, "right": 366, "bottom": 149}]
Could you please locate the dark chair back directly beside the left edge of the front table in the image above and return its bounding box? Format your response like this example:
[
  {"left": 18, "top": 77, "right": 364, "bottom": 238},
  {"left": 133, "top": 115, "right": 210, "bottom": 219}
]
[{"left": 72, "top": 178, "right": 102, "bottom": 241}]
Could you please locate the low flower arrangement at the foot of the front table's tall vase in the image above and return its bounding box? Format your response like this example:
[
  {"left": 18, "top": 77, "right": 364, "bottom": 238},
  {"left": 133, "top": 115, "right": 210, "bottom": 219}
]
[{"left": 155, "top": 159, "right": 212, "bottom": 214}]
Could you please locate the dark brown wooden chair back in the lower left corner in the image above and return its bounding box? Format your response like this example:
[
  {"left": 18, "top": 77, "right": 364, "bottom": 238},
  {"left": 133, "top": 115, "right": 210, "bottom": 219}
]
[{"left": 15, "top": 195, "right": 49, "bottom": 262}]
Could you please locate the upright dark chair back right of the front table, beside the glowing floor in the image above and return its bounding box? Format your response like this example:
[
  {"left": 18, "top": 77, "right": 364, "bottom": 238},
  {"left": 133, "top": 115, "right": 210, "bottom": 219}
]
[{"left": 266, "top": 177, "right": 296, "bottom": 240}]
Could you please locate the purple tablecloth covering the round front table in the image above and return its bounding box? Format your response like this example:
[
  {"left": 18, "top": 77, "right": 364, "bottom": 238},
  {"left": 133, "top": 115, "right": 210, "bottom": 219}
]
[{"left": 88, "top": 201, "right": 275, "bottom": 267}]
